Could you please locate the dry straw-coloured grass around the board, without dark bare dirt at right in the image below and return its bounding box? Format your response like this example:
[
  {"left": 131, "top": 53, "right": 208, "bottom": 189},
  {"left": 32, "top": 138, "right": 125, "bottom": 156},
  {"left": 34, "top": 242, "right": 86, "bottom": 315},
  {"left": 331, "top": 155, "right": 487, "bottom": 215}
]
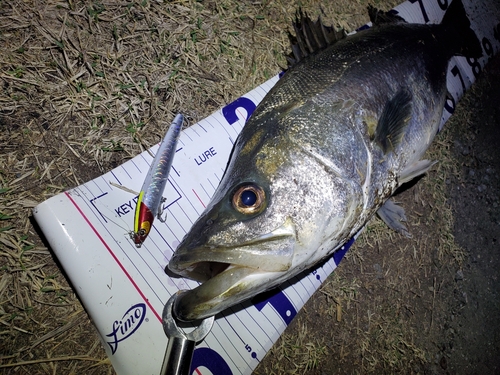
[{"left": 0, "top": 0, "right": 470, "bottom": 374}]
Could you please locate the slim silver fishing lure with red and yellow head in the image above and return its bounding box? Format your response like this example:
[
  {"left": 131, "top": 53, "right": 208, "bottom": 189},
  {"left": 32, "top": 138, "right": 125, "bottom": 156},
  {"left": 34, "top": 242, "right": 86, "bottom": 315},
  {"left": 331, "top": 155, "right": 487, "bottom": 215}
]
[{"left": 130, "top": 114, "right": 184, "bottom": 248}]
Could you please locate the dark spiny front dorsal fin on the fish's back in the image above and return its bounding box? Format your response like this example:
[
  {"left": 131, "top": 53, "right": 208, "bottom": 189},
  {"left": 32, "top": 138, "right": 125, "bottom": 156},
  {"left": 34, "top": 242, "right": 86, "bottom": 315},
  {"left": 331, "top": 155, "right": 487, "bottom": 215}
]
[{"left": 287, "top": 9, "right": 346, "bottom": 67}]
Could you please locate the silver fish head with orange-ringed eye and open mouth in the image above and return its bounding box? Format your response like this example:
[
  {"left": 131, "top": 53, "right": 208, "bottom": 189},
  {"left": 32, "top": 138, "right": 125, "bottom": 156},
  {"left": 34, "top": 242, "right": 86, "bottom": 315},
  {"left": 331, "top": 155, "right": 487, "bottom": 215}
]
[{"left": 168, "top": 114, "right": 360, "bottom": 321}]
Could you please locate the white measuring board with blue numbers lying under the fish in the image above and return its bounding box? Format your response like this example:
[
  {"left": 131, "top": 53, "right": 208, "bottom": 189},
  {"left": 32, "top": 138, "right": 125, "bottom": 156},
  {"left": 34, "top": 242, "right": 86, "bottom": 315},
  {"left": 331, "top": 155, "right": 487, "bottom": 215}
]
[{"left": 34, "top": 0, "right": 500, "bottom": 375}]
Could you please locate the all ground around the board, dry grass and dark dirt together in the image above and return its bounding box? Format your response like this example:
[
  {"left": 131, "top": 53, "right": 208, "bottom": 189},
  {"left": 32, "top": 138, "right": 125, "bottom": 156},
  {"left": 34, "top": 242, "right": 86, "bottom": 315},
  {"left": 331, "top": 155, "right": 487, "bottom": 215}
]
[{"left": 0, "top": 0, "right": 500, "bottom": 374}]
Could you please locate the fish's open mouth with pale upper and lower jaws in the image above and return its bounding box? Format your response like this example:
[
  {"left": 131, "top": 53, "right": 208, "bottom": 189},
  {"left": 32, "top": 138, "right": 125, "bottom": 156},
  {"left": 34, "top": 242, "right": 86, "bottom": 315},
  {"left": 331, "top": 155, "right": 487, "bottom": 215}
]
[{"left": 168, "top": 219, "right": 296, "bottom": 321}]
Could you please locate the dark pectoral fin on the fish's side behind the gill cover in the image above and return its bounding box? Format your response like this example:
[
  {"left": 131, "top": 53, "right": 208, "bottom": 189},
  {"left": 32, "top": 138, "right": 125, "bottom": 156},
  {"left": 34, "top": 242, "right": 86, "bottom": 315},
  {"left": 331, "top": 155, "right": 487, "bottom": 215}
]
[{"left": 374, "top": 88, "right": 412, "bottom": 154}]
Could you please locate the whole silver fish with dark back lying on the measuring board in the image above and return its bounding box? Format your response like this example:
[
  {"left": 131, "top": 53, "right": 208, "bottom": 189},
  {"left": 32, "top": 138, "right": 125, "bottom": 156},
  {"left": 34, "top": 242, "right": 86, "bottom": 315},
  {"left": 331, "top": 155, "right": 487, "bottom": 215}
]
[{"left": 168, "top": 0, "right": 482, "bottom": 321}]
